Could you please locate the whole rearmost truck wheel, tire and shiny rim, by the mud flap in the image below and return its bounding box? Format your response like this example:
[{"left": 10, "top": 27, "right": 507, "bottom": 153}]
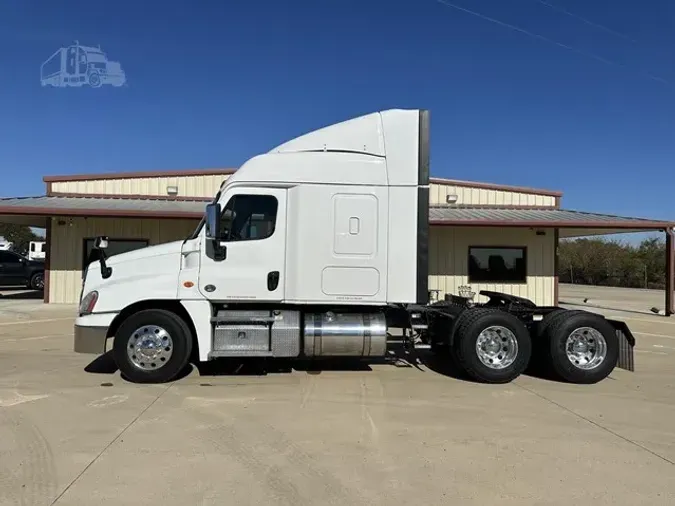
[{"left": 544, "top": 311, "right": 619, "bottom": 384}]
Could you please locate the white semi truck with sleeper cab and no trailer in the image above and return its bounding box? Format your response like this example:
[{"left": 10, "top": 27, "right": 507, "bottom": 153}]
[{"left": 74, "top": 109, "right": 634, "bottom": 383}]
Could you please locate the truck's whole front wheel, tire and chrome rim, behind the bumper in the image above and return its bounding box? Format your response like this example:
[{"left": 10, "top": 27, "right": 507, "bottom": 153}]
[{"left": 113, "top": 309, "right": 192, "bottom": 383}]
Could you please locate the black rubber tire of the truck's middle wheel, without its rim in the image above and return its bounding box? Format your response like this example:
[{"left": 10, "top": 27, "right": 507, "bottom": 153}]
[{"left": 453, "top": 308, "right": 532, "bottom": 383}]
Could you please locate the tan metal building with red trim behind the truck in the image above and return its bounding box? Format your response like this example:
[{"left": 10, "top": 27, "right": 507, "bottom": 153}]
[{"left": 0, "top": 169, "right": 673, "bottom": 311}]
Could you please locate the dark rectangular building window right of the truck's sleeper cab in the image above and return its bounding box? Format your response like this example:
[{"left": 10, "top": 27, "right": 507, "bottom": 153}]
[{"left": 469, "top": 246, "right": 527, "bottom": 283}]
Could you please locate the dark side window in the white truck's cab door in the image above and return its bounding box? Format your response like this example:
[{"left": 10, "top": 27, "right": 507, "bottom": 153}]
[{"left": 220, "top": 195, "right": 279, "bottom": 241}]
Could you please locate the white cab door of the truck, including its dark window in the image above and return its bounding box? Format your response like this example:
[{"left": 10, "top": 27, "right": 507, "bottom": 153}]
[{"left": 199, "top": 187, "right": 287, "bottom": 302}]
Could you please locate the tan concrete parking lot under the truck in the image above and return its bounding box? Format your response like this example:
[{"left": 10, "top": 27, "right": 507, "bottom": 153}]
[{"left": 0, "top": 292, "right": 675, "bottom": 506}]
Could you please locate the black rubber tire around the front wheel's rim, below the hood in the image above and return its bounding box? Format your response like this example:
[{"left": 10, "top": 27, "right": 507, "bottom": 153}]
[{"left": 113, "top": 309, "right": 192, "bottom": 383}]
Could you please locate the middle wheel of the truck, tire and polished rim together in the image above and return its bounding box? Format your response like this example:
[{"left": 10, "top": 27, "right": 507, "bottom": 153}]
[{"left": 453, "top": 308, "right": 532, "bottom": 383}]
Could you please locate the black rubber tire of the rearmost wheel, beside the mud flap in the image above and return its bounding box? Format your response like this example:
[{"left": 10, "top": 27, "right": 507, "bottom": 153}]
[{"left": 544, "top": 311, "right": 619, "bottom": 384}]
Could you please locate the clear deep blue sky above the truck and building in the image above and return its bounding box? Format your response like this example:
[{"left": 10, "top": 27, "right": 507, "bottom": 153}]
[{"left": 0, "top": 0, "right": 675, "bottom": 219}]
